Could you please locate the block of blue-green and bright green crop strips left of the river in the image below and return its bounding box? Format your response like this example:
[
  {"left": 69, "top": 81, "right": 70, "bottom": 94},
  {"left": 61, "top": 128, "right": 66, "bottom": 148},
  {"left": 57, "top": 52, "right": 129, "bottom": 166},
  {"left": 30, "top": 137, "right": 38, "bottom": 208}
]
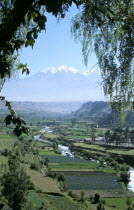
[{"left": 43, "top": 153, "right": 122, "bottom": 193}]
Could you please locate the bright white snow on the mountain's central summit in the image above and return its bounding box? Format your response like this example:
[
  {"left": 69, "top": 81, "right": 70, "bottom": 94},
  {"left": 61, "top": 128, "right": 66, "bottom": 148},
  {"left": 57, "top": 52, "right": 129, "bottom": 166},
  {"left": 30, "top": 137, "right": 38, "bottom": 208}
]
[{"left": 41, "top": 65, "right": 79, "bottom": 74}]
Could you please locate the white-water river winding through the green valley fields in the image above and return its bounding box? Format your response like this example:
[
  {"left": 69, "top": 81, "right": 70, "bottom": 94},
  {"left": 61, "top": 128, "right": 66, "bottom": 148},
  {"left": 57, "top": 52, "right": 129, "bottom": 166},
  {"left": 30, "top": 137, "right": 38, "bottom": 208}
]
[{"left": 34, "top": 126, "right": 134, "bottom": 192}]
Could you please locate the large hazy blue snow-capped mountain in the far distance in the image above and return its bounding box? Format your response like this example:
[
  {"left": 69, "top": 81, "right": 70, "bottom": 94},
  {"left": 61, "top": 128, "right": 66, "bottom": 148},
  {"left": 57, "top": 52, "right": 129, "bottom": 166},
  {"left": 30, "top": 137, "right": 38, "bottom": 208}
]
[{"left": 1, "top": 65, "right": 104, "bottom": 102}]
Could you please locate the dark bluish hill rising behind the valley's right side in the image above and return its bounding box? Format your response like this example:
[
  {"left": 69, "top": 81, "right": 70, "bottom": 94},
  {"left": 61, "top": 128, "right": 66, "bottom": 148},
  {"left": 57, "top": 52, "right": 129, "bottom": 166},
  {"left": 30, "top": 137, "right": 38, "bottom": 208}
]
[{"left": 71, "top": 101, "right": 134, "bottom": 126}]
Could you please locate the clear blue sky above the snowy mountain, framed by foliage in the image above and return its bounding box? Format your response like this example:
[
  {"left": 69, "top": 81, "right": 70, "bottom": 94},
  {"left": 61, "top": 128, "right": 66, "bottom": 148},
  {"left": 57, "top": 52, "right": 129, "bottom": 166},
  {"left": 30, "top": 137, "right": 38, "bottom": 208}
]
[{"left": 20, "top": 6, "right": 97, "bottom": 75}]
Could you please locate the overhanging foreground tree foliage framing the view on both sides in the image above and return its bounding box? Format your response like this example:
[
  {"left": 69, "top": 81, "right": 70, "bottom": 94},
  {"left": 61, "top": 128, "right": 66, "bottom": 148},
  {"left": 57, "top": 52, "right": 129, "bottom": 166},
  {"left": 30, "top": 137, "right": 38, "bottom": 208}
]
[{"left": 0, "top": 0, "right": 134, "bottom": 126}]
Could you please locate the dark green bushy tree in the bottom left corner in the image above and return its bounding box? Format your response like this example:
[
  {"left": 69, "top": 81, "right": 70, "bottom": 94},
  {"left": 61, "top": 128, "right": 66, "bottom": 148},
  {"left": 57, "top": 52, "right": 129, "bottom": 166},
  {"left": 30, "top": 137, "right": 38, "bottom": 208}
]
[{"left": 1, "top": 154, "right": 33, "bottom": 210}]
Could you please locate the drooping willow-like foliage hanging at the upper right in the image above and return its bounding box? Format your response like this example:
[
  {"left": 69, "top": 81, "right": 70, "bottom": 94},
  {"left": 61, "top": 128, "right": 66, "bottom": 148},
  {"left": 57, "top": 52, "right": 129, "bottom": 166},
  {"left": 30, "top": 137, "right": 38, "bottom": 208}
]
[{"left": 72, "top": 0, "right": 134, "bottom": 118}]
